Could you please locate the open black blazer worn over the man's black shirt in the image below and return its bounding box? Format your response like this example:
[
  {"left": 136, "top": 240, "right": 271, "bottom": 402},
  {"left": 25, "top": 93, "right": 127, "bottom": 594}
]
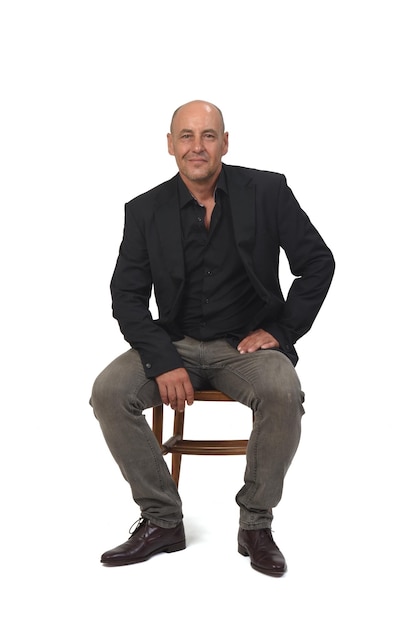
[{"left": 111, "top": 165, "right": 334, "bottom": 378}]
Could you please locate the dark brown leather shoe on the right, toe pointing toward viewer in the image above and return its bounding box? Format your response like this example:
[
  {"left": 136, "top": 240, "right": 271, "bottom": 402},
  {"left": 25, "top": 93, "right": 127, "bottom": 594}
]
[{"left": 237, "top": 528, "right": 287, "bottom": 577}]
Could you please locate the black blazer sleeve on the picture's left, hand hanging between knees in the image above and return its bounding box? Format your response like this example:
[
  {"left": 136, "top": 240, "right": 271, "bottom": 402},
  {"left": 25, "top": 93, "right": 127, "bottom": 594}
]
[{"left": 110, "top": 201, "right": 184, "bottom": 378}]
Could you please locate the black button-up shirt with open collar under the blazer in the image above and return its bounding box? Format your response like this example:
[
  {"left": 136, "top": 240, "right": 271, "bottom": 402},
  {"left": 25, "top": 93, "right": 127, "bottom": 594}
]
[{"left": 178, "top": 172, "right": 263, "bottom": 341}]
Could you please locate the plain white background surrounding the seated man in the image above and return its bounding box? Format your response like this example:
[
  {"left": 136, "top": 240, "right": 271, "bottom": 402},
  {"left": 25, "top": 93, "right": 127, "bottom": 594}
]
[{"left": 0, "top": 0, "right": 417, "bottom": 626}]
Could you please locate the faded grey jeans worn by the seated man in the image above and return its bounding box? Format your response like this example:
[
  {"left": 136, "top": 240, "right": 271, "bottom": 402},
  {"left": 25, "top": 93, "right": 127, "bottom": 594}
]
[{"left": 91, "top": 337, "right": 304, "bottom": 530}]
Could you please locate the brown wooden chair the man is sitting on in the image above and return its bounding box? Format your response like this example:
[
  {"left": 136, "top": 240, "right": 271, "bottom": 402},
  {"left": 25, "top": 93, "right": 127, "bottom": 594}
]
[{"left": 152, "top": 389, "right": 254, "bottom": 486}]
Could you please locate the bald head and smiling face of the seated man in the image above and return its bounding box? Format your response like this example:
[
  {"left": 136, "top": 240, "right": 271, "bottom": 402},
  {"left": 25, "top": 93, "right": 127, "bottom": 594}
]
[{"left": 168, "top": 102, "right": 228, "bottom": 183}]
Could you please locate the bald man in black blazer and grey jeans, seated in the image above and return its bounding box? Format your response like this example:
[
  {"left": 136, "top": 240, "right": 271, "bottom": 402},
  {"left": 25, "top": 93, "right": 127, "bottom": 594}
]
[{"left": 91, "top": 100, "right": 334, "bottom": 577}]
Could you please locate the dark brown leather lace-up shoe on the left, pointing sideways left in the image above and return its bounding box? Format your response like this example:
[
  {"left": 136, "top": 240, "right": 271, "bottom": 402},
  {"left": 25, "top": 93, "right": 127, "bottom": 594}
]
[{"left": 101, "top": 519, "right": 185, "bottom": 565}]
